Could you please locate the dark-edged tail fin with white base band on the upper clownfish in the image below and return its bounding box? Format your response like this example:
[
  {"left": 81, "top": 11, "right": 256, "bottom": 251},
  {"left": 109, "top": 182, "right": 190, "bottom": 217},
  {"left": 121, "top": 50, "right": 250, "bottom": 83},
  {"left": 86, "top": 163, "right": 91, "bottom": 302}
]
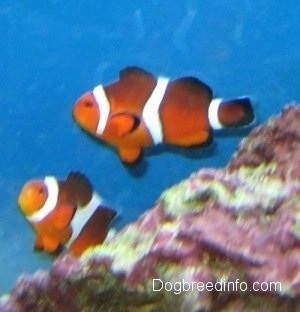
[{"left": 208, "top": 96, "right": 255, "bottom": 129}]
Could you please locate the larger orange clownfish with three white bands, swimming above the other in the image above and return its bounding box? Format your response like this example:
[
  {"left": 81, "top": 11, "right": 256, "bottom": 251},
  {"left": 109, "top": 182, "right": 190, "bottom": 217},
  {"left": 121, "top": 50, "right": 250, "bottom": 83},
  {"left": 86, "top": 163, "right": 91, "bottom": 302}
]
[{"left": 73, "top": 67, "right": 254, "bottom": 163}]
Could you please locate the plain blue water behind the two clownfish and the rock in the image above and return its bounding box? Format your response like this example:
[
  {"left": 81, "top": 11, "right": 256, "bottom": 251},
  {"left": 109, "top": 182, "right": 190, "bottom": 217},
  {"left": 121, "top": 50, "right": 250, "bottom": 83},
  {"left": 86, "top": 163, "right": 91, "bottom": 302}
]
[{"left": 0, "top": 0, "right": 300, "bottom": 294}]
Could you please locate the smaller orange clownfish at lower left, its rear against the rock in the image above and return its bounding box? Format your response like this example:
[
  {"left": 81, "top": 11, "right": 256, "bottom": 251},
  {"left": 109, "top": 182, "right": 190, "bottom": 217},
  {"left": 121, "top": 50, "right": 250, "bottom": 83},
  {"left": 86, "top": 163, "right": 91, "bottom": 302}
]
[{"left": 18, "top": 172, "right": 116, "bottom": 257}]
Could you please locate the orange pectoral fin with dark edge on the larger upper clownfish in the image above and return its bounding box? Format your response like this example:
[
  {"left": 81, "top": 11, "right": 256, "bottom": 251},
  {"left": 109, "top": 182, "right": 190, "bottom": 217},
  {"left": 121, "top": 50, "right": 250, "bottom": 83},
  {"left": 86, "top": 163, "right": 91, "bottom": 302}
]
[{"left": 108, "top": 113, "right": 140, "bottom": 137}]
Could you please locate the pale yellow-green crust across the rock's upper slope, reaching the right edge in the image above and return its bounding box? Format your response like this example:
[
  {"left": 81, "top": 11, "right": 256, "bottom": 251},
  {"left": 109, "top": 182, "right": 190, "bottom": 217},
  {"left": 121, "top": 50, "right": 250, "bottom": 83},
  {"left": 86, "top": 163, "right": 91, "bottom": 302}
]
[{"left": 160, "top": 163, "right": 296, "bottom": 217}]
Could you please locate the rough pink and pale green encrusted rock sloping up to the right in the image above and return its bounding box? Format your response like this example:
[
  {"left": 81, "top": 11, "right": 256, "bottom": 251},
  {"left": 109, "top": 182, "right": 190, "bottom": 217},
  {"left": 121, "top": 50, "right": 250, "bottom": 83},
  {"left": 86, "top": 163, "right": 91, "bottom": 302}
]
[{"left": 0, "top": 104, "right": 300, "bottom": 312}]
